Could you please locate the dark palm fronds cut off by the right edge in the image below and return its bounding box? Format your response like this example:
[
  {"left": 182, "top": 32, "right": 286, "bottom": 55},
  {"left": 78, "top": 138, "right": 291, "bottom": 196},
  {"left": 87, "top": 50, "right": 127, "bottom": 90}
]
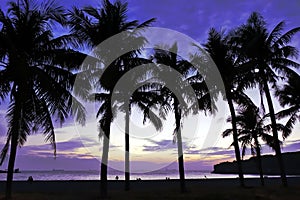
[{"left": 275, "top": 73, "right": 300, "bottom": 134}]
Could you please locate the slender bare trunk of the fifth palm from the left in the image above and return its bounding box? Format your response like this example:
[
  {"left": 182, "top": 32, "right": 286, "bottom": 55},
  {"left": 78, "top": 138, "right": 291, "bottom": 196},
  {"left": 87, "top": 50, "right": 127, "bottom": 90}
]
[{"left": 226, "top": 93, "right": 245, "bottom": 187}]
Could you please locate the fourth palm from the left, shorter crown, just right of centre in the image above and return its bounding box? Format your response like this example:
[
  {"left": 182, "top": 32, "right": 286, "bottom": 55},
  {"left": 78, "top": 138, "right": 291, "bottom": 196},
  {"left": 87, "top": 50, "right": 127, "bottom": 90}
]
[{"left": 151, "top": 43, "right": 210, "bottom": 192}]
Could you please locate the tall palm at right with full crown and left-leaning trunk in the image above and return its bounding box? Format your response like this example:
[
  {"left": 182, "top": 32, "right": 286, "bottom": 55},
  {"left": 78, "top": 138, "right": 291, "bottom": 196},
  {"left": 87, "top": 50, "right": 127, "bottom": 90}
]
[{"left": 235, "top": 12, "right": 300, "bottom": 186}]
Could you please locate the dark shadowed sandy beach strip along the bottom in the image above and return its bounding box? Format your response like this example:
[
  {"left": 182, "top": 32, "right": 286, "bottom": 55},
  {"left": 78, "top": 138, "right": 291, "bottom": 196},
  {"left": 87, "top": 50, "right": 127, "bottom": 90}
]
[{"left": 0, "top": 177, "right": 300, "bottom": 200}]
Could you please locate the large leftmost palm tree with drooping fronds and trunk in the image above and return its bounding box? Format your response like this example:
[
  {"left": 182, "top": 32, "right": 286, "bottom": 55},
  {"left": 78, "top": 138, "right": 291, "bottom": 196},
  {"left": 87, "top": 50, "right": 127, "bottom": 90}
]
[{"left": 0, "top": 0, "right": 85, "bottom": 199}]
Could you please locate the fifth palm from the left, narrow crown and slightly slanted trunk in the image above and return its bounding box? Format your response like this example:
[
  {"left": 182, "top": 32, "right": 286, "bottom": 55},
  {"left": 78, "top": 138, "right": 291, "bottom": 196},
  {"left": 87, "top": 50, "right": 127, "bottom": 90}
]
[{"left": 204, "top": 28, "right": 244, "bottom": 187}]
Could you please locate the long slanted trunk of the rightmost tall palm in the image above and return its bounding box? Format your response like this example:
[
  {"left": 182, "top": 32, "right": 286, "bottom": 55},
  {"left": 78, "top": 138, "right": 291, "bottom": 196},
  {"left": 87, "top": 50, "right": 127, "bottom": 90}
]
[{"left": 263, "top": 76, "right": 288, "bottom": 187}]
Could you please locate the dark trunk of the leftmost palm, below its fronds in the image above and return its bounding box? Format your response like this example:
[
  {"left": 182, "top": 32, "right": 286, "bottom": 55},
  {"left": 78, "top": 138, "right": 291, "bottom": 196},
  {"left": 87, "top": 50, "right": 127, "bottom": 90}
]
[{"left": 6, "top": 134, "right": 18, "bottom": 199}]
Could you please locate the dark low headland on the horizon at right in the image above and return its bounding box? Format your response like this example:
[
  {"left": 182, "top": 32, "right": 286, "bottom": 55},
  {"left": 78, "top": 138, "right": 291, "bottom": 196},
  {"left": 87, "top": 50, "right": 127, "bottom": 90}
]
[{"left": 212, "top": 151, "right": 300, "bottom": 175}]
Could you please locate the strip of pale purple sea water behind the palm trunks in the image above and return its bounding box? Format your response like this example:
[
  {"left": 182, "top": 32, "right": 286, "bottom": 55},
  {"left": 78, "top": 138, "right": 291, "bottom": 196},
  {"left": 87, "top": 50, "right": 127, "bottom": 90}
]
[{"left": 0, "top": 170, "right": 259, "bottom": 181}]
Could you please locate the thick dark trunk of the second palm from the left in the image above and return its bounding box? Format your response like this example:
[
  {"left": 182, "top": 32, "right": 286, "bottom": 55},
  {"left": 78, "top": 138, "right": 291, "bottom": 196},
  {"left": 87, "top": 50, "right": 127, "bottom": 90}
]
[{"left": 100, "top": 123, "right": 110, "bottom": 198}]
